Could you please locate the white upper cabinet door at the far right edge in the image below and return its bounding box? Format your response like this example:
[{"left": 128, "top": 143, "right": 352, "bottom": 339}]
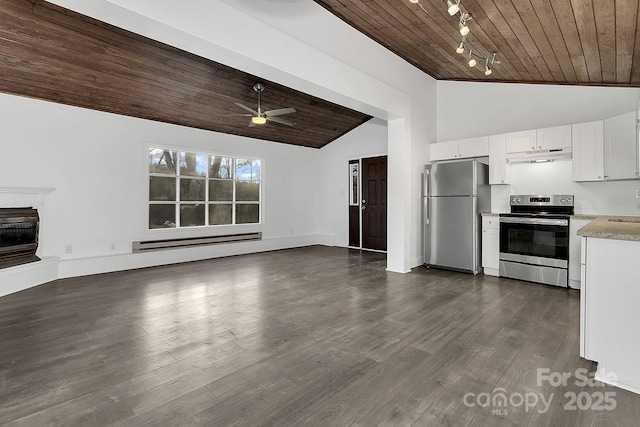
[{"left": 604, "top": 111, "right": 638, "bottom": 180}]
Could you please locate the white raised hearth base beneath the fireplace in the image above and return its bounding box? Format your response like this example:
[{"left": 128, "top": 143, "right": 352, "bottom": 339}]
[{"left": 0, "top": 257, "right": 60, "bottom": 297}]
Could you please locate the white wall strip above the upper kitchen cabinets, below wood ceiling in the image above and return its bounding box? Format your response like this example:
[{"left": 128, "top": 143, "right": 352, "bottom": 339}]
[{"left": 437, "top": 81, "right": 640, "bottom": 141}]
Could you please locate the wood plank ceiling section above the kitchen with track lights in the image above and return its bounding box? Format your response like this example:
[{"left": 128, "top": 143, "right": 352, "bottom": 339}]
[{"left": 314, "top": 0, "right": 640, "bottom": 87}]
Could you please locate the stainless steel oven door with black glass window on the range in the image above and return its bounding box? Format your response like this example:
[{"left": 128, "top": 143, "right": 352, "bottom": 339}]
[{"left": 500, "top": 215, "right": 569, "bottom": 269}]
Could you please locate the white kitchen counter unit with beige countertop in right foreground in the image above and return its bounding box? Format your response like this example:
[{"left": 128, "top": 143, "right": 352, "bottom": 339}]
[{"left": 578, "top": 217, "right": 640, "bottom": 393}]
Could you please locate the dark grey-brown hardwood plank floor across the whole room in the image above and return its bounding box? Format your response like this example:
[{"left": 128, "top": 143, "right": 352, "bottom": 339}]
[{"left": 0, "top": 246, "right": 640, "bottom": 427}]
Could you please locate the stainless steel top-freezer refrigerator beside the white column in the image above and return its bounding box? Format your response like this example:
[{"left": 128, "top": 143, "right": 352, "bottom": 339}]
[{"left": 422, "top": 159, "right": 491, "bottom": 274}]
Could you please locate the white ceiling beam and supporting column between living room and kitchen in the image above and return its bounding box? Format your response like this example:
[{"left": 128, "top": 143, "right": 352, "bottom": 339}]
[{"left": 52, "top": 0, "right": 436, "bottom": 272}]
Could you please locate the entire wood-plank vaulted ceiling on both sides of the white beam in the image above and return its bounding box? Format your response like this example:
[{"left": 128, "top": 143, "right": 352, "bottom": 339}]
[{"left": 0, "top": 0, "right": 640, "bottom": 152}]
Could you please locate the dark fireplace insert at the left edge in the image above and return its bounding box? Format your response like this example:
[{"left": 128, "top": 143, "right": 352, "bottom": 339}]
[{"left": 0, "top": 208, "right": 40, "bottom": 268}]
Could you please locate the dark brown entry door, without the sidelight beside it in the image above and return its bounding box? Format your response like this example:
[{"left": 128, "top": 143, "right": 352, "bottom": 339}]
[{"left": 362, "top": 156, "right": 387, "bottom": 251}]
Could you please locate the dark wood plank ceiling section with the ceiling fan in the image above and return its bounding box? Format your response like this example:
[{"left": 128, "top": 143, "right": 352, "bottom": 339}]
[{"left": 0, "top": 0, "right": 371, "bottom": 148}]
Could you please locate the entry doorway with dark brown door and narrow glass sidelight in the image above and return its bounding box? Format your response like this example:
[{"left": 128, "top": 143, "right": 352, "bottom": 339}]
[{"left": 349, "top": 156, "right": 387, "bottom": 251}]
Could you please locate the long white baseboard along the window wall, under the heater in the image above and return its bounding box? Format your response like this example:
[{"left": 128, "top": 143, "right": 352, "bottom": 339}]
[{"left": 58, "top": 235, "right": 326, "bottom": 279}]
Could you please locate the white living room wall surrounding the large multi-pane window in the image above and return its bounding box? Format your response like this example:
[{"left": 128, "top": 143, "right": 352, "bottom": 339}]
[{"left": 0, "top": 94, "right": 321, "bottom": 276}]
